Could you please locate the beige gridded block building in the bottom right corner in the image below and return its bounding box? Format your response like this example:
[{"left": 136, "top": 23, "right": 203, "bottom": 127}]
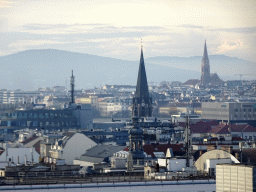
[{"left": 216, "top": 164, "right": 256, "bottom": 192}]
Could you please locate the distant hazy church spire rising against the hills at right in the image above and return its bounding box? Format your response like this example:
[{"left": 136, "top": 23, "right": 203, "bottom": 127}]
[{"left": 201, "top": 40, "right": 211, "bottom": 86}]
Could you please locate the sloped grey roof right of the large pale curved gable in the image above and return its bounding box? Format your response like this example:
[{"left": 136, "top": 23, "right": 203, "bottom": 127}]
[{"left": 80, "top": 145, "right": 126, "bottom": 163}]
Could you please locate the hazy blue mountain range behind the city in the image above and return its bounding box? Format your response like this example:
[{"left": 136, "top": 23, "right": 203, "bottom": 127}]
[{"left": 0, "top": 49, "right": 256, "bottom": 90}]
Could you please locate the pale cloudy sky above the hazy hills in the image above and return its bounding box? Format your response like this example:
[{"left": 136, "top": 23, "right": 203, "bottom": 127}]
[{"left": 0, "top": 0, "right": 256, "bottom": 62}]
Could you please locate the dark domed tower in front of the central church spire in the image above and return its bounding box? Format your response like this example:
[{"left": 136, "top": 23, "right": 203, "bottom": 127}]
[{"left": 128, "top": 117, "right": 145, "bottom": 168}]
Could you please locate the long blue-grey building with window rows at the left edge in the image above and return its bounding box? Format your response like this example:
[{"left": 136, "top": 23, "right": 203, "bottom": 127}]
[{"left": 0, "top": 104, "right": 93, "bottom": 129}]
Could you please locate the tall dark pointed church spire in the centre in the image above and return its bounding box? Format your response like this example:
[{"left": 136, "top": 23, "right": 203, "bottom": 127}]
[{"left": 132, "top": 47, "right": 152, "bottom": 117}]
